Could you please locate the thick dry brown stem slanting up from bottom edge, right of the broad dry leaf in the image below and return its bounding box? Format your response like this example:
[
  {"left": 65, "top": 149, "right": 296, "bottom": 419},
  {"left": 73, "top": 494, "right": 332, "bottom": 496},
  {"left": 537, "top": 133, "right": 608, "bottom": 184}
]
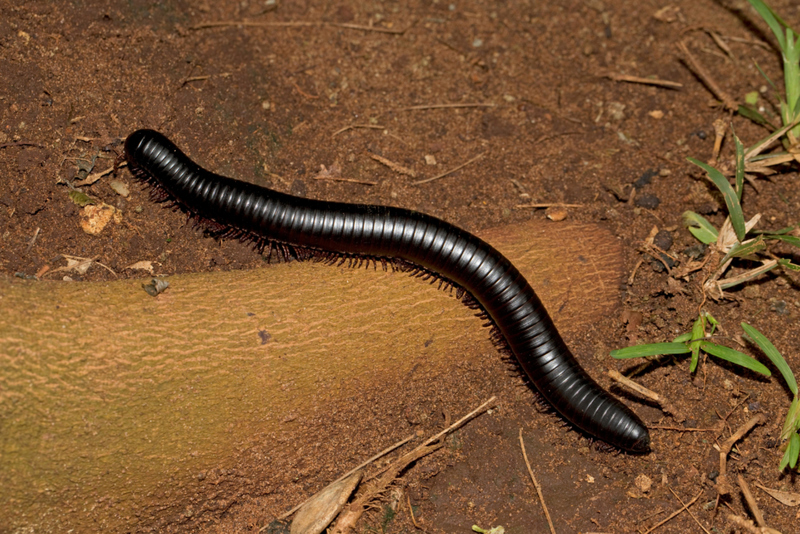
[{"left": 331, "top": 397, "right": 497, "bottom": 534}]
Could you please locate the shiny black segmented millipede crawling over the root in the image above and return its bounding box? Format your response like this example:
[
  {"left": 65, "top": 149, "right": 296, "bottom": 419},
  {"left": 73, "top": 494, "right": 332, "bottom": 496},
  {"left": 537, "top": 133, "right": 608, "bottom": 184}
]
[{"left": 125, "top": 130, "right": 650, "bottom": 453}]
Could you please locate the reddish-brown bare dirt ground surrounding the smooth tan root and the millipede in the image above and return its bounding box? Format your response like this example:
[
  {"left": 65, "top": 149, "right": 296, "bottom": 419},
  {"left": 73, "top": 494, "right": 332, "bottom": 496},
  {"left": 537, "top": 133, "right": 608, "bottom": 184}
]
[{"left": 0, "top": 0, "right": 800, "bottom": 534}]
